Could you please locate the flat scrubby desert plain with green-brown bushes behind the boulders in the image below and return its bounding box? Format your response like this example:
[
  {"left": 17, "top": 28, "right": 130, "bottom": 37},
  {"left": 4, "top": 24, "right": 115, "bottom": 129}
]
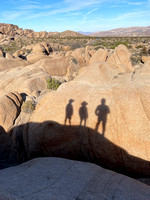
[{"left": 0, "top": 36, "right": 150, "bottom": 65}]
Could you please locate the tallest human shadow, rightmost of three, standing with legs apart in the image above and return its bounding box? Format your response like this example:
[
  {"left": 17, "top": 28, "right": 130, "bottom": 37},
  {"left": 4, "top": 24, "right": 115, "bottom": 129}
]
[{"left": 95, "top": 98, "right": 110, "bottom": 136}]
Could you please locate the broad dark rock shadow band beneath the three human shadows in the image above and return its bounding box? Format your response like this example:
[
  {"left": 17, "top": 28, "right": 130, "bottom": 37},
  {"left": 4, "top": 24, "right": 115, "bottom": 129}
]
[{"left": 0, "top": 121, "right": 150, "bottom": 177}]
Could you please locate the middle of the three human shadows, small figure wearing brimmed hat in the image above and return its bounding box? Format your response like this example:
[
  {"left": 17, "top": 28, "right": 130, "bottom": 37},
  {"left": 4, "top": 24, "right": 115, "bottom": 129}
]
[{"left": 79, "top": 101, "right": 88, "bottom": 126}]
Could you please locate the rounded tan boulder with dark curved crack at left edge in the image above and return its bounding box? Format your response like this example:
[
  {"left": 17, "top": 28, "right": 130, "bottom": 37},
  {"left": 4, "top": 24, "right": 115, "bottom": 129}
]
[{"left": 0, "top": 92, "right": 23, "bottom": 131}]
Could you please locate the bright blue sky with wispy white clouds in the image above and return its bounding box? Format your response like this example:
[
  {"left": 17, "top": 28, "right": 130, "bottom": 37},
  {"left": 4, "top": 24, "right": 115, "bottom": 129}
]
[{"left": 0, "top": 0, "right": 150, "bottom": 32}]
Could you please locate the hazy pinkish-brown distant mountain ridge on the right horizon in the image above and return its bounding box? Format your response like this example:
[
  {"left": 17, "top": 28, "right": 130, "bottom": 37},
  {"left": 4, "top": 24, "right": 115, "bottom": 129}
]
[{"left": 89, "top": 26, "right": 150, "bottom": 37}]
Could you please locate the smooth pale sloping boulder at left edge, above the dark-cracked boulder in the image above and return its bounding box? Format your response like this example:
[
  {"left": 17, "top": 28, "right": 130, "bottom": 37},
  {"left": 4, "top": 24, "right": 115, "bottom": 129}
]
[{"left": 0, "top": 65, "right": 49, "bottom": 97}]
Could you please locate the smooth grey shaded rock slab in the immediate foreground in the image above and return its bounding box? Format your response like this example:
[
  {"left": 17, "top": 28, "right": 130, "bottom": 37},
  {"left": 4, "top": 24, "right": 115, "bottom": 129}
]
[{"left": 0, "top": 158, "right": 150, "bottom": 200}]
